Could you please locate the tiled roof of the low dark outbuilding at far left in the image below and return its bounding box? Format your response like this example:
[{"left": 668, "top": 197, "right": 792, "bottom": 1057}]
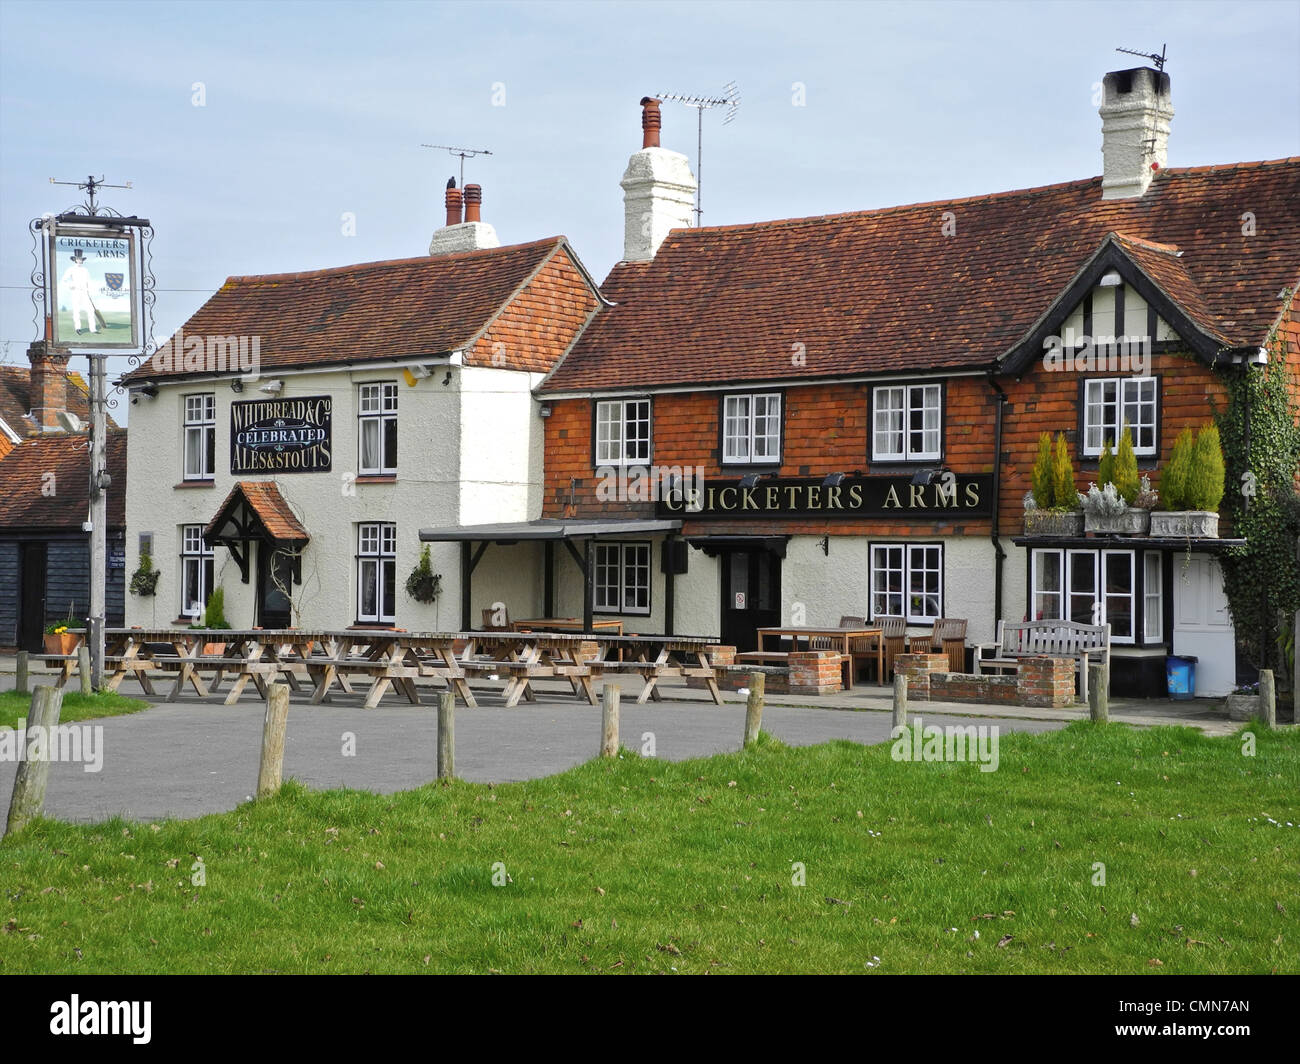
[{"left": 0, "top": 429, "right": 126, "bottom": 532}]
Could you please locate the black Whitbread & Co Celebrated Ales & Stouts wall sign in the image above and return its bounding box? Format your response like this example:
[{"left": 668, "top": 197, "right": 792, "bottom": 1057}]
[{"left": 230, "top": 395, "right": 334, "bottom": 473}]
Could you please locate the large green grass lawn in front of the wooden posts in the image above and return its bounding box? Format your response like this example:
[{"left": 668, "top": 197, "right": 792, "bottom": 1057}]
[{"left": 0, "top": 723, "right": 1300, "bottom": 973}]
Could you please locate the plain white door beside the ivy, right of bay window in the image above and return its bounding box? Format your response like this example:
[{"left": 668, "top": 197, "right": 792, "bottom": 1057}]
[{"left": 1174, "top": 553, "right": 1236, "bottom": 698}]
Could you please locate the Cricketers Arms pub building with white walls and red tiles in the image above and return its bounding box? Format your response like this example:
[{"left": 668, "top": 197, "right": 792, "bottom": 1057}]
[{"left": 119, "top": 68, "right": 1300, "bottom": 695}]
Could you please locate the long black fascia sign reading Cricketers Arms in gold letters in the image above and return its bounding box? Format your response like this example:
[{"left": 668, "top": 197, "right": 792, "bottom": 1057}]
[{"left": 655, "top": 472, "right": 993, "bottom": 520}]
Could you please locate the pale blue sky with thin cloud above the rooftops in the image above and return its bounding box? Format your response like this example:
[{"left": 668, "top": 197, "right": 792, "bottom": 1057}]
[{"left": 0, "top": 0, "right": 1300, "bottom": 420}]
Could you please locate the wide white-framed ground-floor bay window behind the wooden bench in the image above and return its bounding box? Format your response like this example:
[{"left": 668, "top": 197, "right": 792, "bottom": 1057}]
[{"left": 1030, "top": 550, "right": 1144, "bottom": 643}]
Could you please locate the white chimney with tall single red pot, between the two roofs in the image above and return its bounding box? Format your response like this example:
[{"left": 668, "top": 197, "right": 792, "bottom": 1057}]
[{"left": 619, "top": 96, "right": 696, "bottom": 263}]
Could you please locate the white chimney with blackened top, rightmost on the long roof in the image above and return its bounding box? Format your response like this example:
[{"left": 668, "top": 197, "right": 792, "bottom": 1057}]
[{"left": 1101, "top": 66, "right": 1174, "bottom": 199}]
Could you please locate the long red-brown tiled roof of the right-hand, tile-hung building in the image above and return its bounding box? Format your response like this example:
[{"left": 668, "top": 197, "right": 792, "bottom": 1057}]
[{"left": 542, "top": 159, "right": 1300, "bottom": 392}]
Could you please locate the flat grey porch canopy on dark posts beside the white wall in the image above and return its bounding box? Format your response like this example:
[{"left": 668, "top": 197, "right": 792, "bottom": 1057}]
[{"left": 420, "top": 518, "right": 681, "bottom": 635}]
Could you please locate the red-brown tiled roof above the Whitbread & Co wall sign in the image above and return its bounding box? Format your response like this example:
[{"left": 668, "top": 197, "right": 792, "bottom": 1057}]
[{"left": 125, "top": 237, "right": 579, "bottom": 381}]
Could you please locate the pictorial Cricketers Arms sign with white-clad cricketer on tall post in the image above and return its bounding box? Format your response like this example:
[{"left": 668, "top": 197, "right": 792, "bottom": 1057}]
[{"left": 48, "top": 222, "right": 139, "bottom": 350}]
